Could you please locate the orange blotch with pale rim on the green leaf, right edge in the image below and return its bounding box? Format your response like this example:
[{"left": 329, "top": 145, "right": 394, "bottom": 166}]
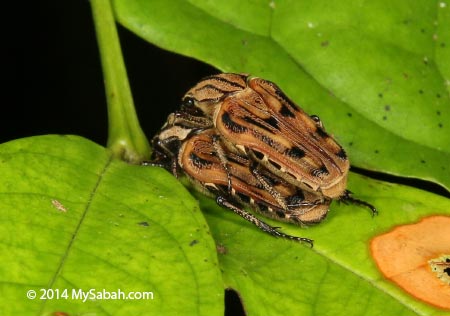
[{"left": 370, "top": 216, "right": 450, "bottom": 310}]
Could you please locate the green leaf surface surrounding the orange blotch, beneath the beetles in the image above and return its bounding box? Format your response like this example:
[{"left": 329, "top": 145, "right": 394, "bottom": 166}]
[{"left": 199, "top": 175, "right": 450, "bottom": 315}]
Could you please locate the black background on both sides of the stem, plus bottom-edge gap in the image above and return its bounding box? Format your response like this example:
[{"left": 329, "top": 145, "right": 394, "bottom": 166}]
[{"left": 0, "top": 0, "right": 243, "bottom": 315}]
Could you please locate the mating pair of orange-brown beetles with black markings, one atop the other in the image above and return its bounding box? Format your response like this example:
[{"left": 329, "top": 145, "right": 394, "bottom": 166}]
[{"left": 152, "top": 74, "right": 377, "bottom": 244}]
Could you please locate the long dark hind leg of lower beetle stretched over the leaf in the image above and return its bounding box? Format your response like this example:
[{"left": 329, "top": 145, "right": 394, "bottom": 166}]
[{"left": 216, "top": 195, "right": 313, "bottom": 247}]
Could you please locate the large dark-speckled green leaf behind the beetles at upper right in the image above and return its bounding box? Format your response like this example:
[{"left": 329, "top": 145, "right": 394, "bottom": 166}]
[{"left": 114, "top": 0, "right": 450, "bottom": 190}]
